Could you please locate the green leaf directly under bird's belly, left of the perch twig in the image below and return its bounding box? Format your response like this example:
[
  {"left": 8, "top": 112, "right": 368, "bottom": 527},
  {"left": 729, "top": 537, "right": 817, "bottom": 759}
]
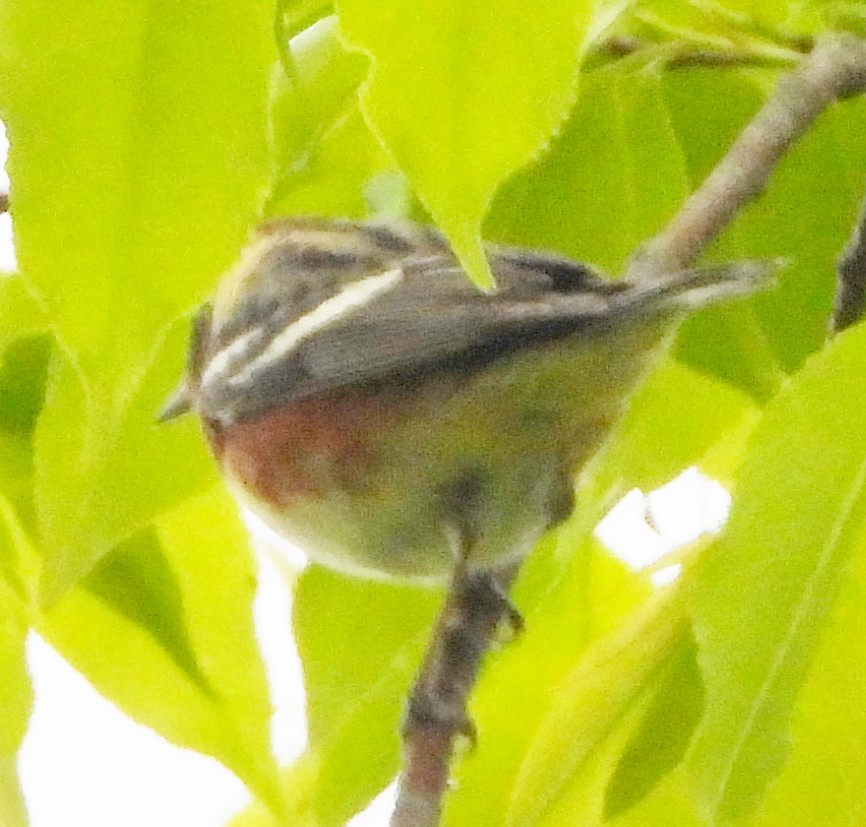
[{"left": 294, "top": 567, "right": 441, "bottom": 827}]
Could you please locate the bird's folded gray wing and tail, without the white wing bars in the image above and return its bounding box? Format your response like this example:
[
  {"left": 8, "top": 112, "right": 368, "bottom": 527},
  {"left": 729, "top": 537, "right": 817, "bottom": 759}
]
[{"left": 202, "top": 241, "right": 768, "bottom": 421}]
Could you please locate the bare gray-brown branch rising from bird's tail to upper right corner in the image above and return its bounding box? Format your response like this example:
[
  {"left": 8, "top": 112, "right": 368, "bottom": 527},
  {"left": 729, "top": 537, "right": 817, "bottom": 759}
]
[{"left": 628, "top": 34, "right": 866, "bottom": 278}]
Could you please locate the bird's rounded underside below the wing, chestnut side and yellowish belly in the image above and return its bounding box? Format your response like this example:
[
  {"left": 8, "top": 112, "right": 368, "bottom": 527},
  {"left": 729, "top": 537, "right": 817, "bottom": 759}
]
[{"left": 214, "top": 324, "right": 658, "bottom": 579}]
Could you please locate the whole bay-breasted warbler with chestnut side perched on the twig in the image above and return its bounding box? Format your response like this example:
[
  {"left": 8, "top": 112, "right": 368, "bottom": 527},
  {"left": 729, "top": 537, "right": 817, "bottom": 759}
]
[{"left": 164, "top": 219, "right": 768, "bottom": 579}]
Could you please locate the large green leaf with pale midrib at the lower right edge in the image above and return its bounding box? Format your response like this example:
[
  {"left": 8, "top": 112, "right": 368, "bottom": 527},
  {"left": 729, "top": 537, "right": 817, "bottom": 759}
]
[{"left": 688, "top": 328, "right": 866, "bottom": 819}]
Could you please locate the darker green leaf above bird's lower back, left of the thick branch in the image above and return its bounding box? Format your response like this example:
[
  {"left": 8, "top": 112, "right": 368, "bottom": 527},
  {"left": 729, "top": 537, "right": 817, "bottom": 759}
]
[{"left": 485, "top": 61, "right": 688, "bottom": 272}]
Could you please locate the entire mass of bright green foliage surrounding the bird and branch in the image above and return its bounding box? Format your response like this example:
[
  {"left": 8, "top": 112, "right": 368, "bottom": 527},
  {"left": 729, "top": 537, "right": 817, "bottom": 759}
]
[{"left": 0, "top": 0, "right": 866, "bottom": 827}]
